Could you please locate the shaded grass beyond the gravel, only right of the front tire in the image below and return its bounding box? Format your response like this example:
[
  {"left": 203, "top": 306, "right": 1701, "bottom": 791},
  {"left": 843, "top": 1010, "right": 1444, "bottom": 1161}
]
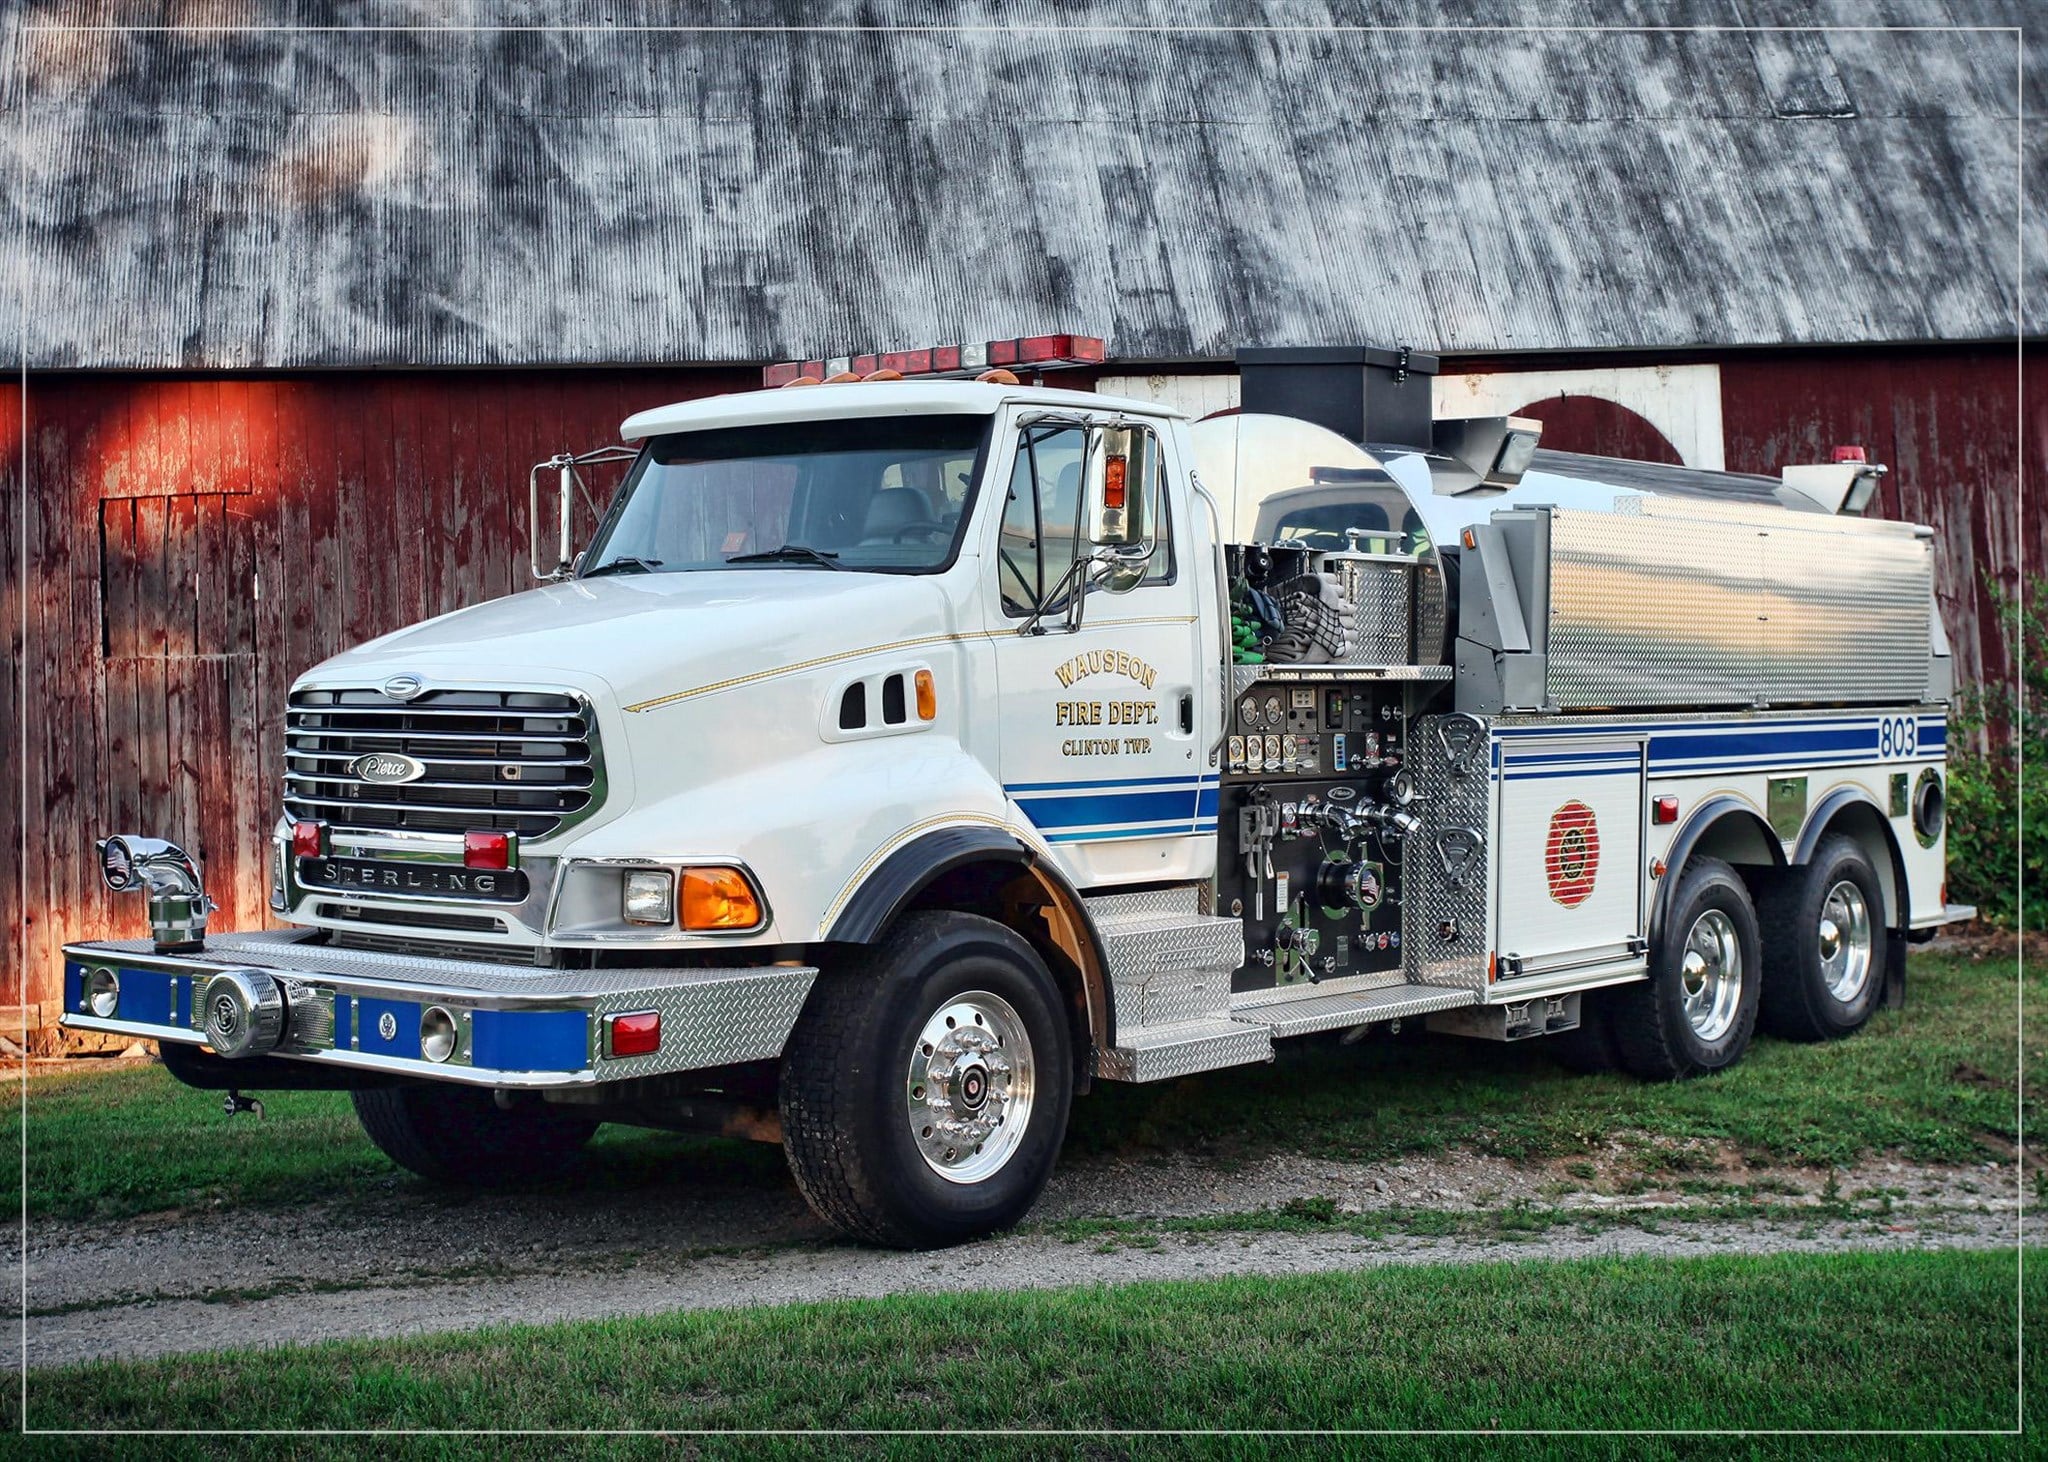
[{"left": 1067, "top": 950, "right": 2023, "bottom": 1171}]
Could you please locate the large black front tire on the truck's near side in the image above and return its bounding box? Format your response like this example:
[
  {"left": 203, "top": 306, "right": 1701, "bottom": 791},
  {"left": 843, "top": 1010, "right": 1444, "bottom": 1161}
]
[{"left": 780, "top": 913, "right": 1073, "bottom": 1249}]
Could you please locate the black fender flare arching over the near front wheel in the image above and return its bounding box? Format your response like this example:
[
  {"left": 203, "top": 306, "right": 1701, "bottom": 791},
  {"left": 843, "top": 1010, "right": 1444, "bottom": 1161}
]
[{"left": 825, "top": 827, "right": 1116, "bottom": 1055}]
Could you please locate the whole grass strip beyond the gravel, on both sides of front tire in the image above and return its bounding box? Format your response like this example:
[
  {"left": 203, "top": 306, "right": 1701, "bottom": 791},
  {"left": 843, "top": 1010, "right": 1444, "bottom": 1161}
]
[{"left": 6, "top": 950, "right": 2048, "bottom": 1218}]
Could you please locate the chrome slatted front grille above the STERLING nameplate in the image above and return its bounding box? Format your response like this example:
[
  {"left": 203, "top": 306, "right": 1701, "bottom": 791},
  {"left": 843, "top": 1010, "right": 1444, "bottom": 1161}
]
[{"left": 285, "top": 690, "right": 602, "bottom": 837}]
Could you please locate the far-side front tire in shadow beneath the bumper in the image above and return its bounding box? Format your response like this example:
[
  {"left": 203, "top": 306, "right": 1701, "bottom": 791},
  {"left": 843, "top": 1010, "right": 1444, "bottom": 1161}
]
[{"left": 350, "top": 1083, "right": 598, "bottom": 1188}]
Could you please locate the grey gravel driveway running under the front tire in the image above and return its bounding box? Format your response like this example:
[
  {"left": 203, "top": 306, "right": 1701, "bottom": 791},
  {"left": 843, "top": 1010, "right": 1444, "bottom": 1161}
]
[{"left": 0, "top": 1157, "right": 2019, "bottom": 1368}]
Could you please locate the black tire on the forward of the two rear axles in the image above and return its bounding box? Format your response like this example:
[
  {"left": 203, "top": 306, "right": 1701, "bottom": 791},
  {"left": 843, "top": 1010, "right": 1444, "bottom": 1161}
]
[{"left": 1612, "top": 858, "right": 1763, "bottom": 1081}]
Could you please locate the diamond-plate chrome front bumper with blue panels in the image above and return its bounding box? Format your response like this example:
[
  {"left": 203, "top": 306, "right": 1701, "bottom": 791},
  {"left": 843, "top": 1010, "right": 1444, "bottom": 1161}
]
[{"left": 63, "top": 930, "right": 817, "bottom": 1087}]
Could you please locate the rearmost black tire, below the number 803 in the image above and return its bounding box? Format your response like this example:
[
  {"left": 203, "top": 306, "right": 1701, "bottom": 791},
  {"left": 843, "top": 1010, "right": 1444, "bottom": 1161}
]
[{"left": 1757, "top": 833, "right": 1890, "bottom": 1040}]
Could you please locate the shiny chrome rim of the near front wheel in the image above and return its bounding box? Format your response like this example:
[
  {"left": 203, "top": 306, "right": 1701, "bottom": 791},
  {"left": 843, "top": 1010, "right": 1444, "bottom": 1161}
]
[{"left": 903, "top": 989, "right": 1036, "bottom": 1184}]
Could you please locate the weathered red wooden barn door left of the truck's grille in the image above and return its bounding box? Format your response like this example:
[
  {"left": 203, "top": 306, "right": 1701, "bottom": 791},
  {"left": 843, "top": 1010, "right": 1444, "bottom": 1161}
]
[{"left": 100, "top": 493, "right": 279, "bottom": 928}]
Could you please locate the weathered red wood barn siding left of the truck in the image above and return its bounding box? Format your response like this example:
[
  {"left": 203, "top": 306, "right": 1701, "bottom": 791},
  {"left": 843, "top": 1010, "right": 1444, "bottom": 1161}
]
[{"left": 0, "top": 371, "right": 760, "bottom": 1022}]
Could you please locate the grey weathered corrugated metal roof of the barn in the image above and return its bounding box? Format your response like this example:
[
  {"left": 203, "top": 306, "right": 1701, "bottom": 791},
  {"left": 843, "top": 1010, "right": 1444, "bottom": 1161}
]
[{"left": 0, "top": 0, "right": 2048, "bottom": 367}]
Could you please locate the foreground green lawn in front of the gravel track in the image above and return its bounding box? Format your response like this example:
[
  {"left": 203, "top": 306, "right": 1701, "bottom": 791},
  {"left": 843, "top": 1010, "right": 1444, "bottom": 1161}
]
[{"left": 12, "top": 1253, "right": 2048, "bottom": 1433}]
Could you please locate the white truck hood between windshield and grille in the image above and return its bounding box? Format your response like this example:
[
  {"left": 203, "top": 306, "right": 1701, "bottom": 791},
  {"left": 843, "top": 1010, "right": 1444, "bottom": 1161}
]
[{"left": 307, "top": 567, "right": 958, "bottom": 704}]
